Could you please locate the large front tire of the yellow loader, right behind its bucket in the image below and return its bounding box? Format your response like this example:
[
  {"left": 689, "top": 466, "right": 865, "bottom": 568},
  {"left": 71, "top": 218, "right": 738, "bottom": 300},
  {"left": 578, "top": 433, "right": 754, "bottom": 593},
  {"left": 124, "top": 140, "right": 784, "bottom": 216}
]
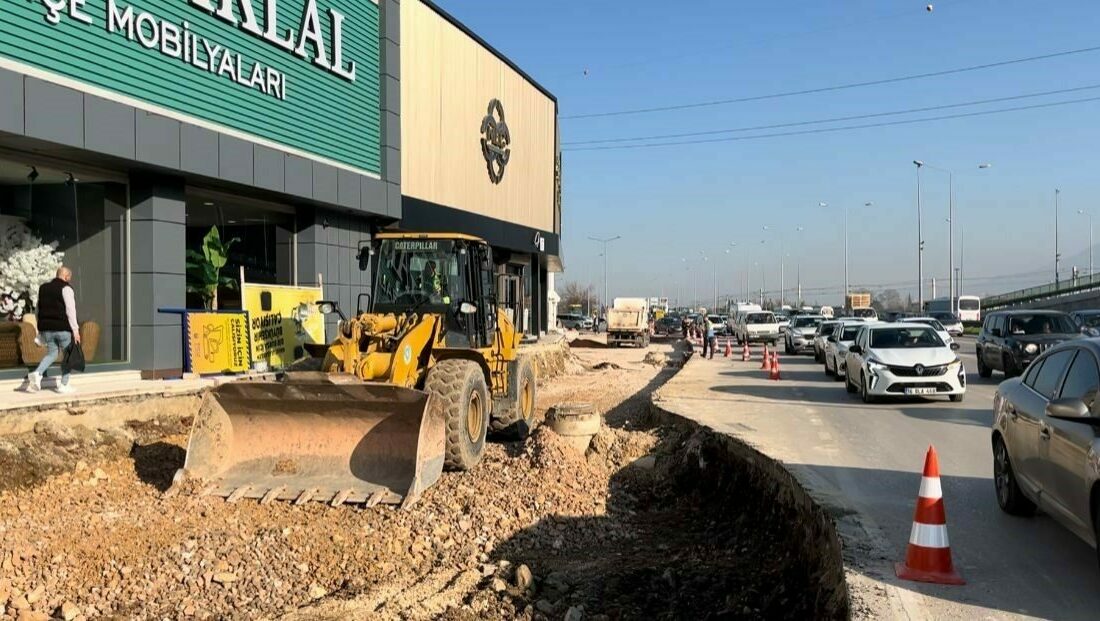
[{"left": 424, "top": 359, "right": 490, "bottom": 470}]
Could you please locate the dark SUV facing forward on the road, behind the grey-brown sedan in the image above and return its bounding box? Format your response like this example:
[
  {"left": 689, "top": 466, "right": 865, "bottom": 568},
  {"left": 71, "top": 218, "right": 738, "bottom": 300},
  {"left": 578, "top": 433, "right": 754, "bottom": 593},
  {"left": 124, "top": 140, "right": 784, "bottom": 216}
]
[{"left": 978, "top": 310, "right": 1081, "bottom": 377}]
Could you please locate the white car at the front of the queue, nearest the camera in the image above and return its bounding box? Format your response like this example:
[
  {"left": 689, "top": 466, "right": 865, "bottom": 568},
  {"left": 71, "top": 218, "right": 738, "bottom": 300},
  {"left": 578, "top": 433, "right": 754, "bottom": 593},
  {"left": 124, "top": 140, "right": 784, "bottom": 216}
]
[{"left": 844, "top": 322, "right": 966, "bottom": 403}]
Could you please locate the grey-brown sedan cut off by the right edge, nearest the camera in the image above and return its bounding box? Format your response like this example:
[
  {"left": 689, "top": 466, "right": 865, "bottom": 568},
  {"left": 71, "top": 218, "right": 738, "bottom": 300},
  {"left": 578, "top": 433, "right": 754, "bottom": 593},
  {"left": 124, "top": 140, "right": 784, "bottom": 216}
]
[{"left": 992, "top": 339, "right": 1100, "bottom": 562}]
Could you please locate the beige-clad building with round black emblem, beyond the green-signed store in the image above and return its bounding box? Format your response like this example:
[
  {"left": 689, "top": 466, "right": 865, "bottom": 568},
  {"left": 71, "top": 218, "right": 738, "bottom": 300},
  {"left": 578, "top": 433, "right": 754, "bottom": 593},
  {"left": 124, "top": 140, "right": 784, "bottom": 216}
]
[{"left": 398, "top": 0, "right": 562, "bottom": 334}]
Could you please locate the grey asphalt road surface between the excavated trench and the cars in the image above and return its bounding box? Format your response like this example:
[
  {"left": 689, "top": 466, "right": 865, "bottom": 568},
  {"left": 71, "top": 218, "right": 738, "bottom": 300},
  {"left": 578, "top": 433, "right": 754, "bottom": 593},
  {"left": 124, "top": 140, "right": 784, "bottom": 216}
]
[{"left": 662, "top": 337, "right": 1100, "bottom": 619}]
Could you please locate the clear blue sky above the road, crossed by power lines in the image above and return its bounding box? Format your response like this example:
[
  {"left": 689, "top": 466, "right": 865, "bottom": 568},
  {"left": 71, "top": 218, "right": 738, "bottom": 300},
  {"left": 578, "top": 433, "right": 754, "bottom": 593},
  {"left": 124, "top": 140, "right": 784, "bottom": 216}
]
[{"left": 441, "top": 0, "right": 1100, "bottom": 303}]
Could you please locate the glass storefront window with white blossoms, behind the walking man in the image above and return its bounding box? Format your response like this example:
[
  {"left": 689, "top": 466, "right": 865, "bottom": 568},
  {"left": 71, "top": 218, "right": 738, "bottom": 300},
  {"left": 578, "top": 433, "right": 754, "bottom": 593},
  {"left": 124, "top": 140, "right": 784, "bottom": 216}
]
[{"left": 0, "top": 156, "right": 129, "bottom": 369}]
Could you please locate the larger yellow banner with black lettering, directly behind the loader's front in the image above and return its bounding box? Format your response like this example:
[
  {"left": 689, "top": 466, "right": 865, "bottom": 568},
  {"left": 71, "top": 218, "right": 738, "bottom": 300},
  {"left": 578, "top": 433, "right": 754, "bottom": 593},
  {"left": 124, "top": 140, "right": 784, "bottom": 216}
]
[{"left": 241, "top": 278, "right": 325, "bottom": 369}]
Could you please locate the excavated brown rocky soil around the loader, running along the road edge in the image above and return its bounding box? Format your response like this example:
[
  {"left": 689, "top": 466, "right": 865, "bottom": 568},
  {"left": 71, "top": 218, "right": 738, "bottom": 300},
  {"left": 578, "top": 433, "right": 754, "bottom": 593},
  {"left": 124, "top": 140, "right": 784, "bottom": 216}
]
[{"left": 0, "top": 336, "right": 840, "bottom": 621}]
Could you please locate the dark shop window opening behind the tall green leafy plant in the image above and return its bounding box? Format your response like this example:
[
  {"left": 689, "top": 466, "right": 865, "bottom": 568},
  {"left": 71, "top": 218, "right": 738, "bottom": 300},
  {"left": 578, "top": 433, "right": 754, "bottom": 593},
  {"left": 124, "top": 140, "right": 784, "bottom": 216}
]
[{"left": 186, "top": 190, "right": 295, "bottom": 310}]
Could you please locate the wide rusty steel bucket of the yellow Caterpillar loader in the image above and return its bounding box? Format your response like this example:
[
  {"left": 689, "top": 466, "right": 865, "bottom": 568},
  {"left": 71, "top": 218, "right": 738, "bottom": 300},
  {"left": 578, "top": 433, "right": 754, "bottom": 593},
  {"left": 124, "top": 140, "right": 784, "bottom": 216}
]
[{"left": 176, "top": 373, "right": 446, "bottom": 506}]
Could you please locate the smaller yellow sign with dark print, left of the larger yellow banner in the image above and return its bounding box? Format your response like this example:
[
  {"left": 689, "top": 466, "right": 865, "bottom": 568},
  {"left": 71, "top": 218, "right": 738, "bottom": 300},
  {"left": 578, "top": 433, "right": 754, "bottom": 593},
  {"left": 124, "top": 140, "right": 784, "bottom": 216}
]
[{"left": 184, "top": 312, "right": 251, "bottom": 374}]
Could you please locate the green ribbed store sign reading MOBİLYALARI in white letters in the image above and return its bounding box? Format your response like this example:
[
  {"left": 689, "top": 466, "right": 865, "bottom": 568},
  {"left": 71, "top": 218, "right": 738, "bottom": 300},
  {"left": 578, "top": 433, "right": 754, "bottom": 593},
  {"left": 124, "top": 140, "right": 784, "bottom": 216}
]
[{"left": 0, "top": 0, "right": 382, "bottom": 174}]
